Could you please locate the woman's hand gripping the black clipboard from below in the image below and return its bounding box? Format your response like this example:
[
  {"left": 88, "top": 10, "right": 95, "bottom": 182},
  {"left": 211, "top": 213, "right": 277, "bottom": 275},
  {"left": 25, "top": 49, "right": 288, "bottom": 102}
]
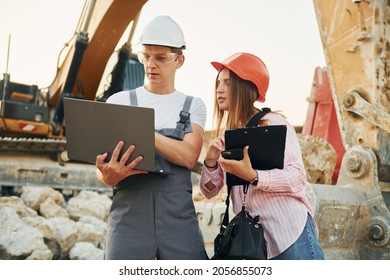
[{"left": 219, "top": 146, "right": 257, "bottom": 182}]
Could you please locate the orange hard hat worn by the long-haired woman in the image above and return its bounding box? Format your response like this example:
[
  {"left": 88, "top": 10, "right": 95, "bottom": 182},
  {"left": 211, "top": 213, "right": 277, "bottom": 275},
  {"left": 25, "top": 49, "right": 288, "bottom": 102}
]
[{"left": 211, "top": 53, "right": 269, "bottom": 102}]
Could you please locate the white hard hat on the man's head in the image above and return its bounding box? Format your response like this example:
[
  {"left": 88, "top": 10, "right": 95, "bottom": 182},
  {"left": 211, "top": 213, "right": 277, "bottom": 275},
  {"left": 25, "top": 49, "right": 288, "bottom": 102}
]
[{"left": 139, "top": 15, "right": 186, "bottom": 48}]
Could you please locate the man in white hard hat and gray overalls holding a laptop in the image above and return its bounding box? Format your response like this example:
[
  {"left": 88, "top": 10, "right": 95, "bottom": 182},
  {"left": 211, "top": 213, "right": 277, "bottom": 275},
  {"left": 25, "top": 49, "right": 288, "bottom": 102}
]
[{"left": 96, "top": 16, "right": 208, "bottom": 260}]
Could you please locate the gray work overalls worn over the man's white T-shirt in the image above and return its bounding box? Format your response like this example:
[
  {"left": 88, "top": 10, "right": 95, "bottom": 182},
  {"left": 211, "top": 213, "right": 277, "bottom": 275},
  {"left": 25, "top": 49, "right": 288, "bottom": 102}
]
[{"left": 105, "top": 91, "right": 208, "bottom": 260}]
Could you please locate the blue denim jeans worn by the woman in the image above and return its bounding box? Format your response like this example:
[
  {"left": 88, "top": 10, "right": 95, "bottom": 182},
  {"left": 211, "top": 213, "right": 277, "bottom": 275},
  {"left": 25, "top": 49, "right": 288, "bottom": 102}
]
[{"left": 272, "top": 215, "right": 324, "bottom": 260}]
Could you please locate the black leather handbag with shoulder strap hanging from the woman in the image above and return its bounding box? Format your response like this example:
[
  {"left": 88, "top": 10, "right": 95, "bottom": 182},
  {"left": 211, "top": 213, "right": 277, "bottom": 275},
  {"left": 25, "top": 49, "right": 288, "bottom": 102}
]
[{"left": 211, "top": 108, "right": 270, "bottom": 260}]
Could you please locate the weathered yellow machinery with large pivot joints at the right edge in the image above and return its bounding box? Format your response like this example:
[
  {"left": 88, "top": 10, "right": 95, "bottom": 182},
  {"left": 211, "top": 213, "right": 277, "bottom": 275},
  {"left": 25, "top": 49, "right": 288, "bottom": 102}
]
[{"left": 303, "top": 0, "right": 390, "bottom": 260}]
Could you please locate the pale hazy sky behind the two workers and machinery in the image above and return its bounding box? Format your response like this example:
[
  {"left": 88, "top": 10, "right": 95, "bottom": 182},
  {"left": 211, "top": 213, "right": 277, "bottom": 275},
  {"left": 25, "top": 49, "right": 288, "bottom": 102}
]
[{"left": 0, "top": 0, "right": 326, "bottom": 129}]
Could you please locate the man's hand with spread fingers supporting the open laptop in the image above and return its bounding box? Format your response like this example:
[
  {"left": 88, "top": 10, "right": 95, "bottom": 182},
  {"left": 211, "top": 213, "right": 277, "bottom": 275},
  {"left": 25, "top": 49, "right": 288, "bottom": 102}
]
[{"left": 95, "top": 141, "right": 148, "bottom": 186}]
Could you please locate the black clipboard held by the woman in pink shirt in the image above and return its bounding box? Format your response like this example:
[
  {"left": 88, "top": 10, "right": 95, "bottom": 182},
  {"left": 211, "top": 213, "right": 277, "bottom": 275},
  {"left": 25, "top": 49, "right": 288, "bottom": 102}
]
[{"left": 225, "top": 125, "right": 287, "bottom": 186}]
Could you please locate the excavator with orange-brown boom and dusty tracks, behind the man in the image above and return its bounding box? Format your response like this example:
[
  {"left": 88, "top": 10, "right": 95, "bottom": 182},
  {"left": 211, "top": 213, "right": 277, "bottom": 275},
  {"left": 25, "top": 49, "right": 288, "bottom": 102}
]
[{"left": 0, "top": 0, "right": 147, "bottom": 195}]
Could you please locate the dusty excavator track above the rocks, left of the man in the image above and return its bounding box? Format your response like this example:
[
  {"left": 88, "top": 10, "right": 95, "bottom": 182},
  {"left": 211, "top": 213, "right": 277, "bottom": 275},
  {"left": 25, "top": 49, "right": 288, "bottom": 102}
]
[{"left": 0, "top": 137, "right": 112, "bottom": 196}]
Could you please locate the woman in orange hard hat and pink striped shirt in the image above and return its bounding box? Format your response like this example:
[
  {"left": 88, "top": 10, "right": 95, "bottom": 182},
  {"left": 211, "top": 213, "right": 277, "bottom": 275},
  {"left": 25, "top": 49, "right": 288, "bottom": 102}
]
[{"left": 200, "top": 53, "right": 324, "bottom": 260}]
